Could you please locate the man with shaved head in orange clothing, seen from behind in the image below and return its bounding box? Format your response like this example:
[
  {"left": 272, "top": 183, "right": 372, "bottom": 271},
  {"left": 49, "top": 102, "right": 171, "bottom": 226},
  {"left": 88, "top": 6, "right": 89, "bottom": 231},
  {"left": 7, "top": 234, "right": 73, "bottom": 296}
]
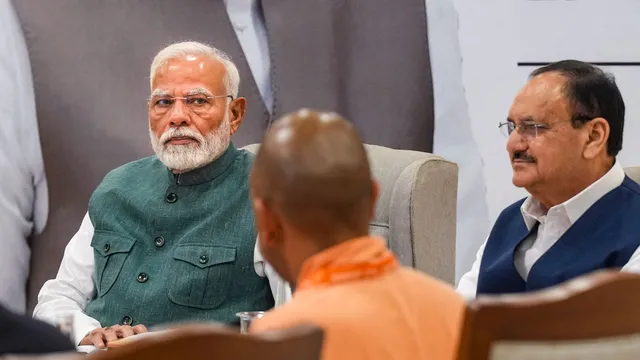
[{"left": 250, "top": 109, "right": 463, "bottom": 360}]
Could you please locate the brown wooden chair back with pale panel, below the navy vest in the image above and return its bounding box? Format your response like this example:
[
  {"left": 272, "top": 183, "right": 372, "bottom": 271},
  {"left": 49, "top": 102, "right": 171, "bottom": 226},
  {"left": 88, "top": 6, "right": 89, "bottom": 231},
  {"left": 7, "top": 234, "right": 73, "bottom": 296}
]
[{"left": 458, "top": 270, "right": 640, "bottom": 360}]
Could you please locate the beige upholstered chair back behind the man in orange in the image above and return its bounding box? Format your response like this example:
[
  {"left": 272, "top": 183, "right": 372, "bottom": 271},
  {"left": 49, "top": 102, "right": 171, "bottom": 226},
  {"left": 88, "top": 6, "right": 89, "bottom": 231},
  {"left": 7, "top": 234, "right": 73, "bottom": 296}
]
[{"left": 244, "top": 144, "right": 458, "bottom": 283}]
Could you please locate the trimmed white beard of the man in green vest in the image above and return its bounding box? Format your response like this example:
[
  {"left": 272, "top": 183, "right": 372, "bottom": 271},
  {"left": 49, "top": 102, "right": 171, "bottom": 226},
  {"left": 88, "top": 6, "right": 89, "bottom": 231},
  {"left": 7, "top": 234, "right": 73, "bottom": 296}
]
[{"left": 149, "top": 111, "right": 231, "bottom": 172}]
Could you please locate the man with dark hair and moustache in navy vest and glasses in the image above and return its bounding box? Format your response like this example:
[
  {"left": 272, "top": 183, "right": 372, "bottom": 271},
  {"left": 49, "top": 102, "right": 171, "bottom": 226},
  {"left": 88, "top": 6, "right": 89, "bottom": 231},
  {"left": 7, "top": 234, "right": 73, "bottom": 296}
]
[{"left": 458, "top": 60, "right": 640, "bottom": 297}]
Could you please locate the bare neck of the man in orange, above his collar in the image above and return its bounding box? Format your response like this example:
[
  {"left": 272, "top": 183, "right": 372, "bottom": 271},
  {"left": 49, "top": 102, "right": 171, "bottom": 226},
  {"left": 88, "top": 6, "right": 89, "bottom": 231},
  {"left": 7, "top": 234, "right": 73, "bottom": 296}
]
[{"left": 287, "top": 226, "right": 369, "bottom": 286}]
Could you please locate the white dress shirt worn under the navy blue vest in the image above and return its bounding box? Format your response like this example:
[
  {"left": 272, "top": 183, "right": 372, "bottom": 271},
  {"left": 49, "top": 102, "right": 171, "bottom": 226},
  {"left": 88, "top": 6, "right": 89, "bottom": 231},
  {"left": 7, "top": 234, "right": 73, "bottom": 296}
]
[{"left": 457, "top": 163, "right": 640, "bottom": 298}]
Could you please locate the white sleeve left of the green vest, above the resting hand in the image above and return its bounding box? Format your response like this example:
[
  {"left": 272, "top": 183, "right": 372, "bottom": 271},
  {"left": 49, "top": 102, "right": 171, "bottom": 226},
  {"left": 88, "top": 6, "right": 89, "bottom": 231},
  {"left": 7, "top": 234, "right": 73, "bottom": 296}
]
[{"left": 33, "top": 214, "right": 101, "bottom": 345}]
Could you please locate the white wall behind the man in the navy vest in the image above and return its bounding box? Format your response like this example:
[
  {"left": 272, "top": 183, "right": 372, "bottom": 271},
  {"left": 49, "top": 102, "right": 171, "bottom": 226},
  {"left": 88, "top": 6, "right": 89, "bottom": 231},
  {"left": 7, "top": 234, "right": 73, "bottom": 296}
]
[{"left": 455, "top": 0, "right": 640, "bottom": 242}]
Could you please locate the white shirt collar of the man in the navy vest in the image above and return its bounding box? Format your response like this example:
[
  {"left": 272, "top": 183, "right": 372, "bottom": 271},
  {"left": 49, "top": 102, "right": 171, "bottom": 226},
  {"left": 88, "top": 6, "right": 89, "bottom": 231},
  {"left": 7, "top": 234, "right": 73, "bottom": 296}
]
[{"left": 520, "top": 162, "right": 625, "bottom": 230}]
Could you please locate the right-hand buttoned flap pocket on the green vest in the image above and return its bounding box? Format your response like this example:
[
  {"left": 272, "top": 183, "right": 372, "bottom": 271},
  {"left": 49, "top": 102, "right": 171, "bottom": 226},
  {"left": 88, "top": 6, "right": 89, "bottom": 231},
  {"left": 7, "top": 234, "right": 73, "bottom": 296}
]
[{"left": 166, "top": 244, "right": 236, "bottom": 309}]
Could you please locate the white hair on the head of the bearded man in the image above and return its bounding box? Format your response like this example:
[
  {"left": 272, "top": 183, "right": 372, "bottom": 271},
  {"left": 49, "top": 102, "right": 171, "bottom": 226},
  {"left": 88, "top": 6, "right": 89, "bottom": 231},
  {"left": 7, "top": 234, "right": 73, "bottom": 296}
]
[{"left": 149, "top": 41, "right": 240, "bottom": 99}]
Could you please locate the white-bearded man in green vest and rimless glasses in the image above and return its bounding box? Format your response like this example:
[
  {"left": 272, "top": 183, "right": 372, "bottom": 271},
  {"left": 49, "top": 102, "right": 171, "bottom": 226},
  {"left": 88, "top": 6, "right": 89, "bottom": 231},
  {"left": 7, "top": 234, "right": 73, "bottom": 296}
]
[{"left": 34, "top": 42, "right": 287, "bottom": 348}]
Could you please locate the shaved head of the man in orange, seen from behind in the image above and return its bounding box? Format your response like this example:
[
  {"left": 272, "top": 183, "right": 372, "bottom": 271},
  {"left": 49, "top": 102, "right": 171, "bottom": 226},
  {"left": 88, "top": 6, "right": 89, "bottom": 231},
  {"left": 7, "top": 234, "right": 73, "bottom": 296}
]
[{"left": 251, "top": 109, "right": 375, "bottom": 236}]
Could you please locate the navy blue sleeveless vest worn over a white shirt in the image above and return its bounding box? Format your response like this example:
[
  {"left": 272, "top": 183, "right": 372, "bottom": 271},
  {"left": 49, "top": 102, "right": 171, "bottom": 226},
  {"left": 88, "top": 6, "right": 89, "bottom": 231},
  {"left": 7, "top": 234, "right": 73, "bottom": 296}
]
[{"left": 476, "top": 177, "right": 640, "bottom": 295}]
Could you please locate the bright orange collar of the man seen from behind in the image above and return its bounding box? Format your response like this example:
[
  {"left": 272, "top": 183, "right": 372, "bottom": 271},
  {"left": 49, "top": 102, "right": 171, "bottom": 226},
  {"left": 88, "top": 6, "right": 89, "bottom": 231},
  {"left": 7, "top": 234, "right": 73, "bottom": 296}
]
[{"left": 296, "top": 236, "right": 400, "bottom": 291}]
